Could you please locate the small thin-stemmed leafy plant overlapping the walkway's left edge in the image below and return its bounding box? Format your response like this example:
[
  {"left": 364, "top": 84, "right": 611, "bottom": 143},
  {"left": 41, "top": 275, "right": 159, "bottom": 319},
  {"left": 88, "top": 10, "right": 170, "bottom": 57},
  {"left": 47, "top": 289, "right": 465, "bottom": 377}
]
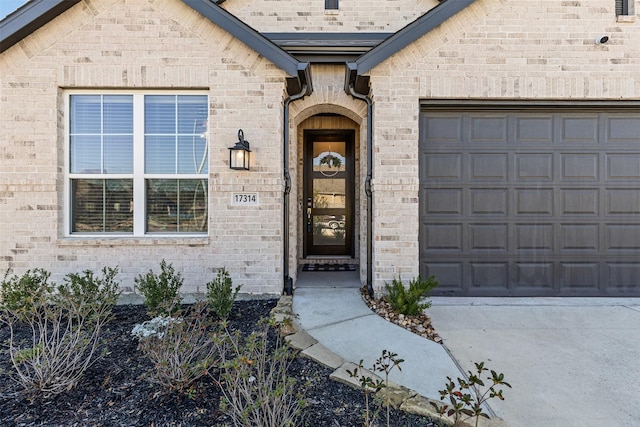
[{"left": 347, "top": 350, "right": 404, "bottom": 427}]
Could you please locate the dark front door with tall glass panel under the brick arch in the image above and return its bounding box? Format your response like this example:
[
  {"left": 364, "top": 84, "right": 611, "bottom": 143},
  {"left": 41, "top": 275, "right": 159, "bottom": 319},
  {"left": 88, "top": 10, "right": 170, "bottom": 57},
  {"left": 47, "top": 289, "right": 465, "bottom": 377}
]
[{"left": 303, "top": 130, "right": 355, "bottom": 257}]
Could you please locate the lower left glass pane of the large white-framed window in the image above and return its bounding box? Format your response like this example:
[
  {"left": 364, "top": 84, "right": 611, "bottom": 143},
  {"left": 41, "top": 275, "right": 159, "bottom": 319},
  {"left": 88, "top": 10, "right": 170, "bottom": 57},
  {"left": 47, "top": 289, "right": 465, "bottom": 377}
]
[{"left": 71, "top": 179, "right": 133, "bottom": 233}]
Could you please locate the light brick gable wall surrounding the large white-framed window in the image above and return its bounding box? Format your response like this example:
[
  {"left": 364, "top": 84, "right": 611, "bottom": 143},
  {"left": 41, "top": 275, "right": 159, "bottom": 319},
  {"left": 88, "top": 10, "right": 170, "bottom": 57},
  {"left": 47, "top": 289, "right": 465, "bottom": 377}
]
[{"left": 0, "top": 0, "right": 285, "bottom": 294}]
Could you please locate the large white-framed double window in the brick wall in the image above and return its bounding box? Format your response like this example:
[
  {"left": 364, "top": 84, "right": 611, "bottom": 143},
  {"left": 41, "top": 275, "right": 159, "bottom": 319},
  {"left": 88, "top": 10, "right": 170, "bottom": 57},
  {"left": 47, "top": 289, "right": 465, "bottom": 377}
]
[{"left": 65, "top": 91, "right": 209, "bottom": 236}]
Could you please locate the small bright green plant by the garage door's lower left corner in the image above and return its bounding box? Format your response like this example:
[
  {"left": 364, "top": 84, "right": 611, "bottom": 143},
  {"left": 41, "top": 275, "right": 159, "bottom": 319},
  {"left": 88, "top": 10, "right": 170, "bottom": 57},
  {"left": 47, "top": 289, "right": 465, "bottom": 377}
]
[{"left": 384, "top": 276, "right": 439, "bottom": 316}]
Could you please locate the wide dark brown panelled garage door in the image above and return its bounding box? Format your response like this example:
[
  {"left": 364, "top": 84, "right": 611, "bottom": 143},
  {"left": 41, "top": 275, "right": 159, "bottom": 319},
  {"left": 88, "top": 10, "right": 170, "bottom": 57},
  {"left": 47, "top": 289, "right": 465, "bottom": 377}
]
[{"left": 420, "top": 106, "right": 640, "bottom": 296}]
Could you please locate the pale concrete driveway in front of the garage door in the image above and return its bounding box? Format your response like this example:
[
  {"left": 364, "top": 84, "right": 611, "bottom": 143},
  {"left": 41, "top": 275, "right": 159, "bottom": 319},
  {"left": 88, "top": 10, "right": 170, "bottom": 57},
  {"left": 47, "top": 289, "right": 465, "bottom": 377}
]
[{"left": 427, "top": 297, "right": 640, "bottom": 427}]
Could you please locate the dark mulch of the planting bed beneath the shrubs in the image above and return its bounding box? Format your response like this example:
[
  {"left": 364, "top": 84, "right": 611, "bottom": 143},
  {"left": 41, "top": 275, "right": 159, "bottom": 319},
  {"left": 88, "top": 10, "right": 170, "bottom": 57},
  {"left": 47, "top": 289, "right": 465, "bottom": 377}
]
[{"left": 0, "top": 300, "right": 444, "bottom": 427}]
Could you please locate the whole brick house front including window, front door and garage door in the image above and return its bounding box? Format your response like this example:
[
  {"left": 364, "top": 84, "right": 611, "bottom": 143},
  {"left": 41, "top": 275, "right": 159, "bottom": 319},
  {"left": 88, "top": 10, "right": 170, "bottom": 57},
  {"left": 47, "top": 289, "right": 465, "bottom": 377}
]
[{"left": 0, "top": 0, "right": 640, "bottom": 295}]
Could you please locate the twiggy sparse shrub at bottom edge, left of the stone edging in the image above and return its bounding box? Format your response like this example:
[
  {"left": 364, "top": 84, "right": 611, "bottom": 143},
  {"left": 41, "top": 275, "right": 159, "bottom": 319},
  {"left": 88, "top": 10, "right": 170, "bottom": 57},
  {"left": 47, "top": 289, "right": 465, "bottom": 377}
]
[{"left": 218, "top": 320, "right": 307, "bottom": 427}]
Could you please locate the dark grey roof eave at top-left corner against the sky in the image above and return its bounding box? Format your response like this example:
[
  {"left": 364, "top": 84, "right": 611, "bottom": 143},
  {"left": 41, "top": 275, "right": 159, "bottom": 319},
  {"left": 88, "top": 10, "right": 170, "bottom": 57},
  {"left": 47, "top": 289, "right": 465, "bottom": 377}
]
[{"left": 0, "top": 0, "right": 81, "bottom": 53}]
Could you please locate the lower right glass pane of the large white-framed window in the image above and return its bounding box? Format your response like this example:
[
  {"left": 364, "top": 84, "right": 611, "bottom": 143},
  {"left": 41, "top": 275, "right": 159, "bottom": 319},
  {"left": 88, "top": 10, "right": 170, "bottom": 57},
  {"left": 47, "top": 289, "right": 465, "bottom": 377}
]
[{"left": 147, "top": 179, "right": 208, "bottom": 233}]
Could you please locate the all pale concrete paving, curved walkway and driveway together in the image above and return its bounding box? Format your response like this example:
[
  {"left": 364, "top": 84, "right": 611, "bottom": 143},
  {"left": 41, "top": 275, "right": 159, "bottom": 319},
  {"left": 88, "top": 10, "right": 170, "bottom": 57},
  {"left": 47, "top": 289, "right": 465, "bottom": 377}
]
[{"left": 293, "top": 272, "right": 640, "bottom": 427}]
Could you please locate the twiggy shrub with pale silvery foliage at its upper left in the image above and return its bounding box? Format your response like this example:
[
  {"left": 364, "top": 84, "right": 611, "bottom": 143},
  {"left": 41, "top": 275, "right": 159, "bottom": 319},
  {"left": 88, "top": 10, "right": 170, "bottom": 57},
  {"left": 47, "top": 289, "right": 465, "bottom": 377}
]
[{"left": 131, "top": 301, "right": 221, "bottom": 393}]
